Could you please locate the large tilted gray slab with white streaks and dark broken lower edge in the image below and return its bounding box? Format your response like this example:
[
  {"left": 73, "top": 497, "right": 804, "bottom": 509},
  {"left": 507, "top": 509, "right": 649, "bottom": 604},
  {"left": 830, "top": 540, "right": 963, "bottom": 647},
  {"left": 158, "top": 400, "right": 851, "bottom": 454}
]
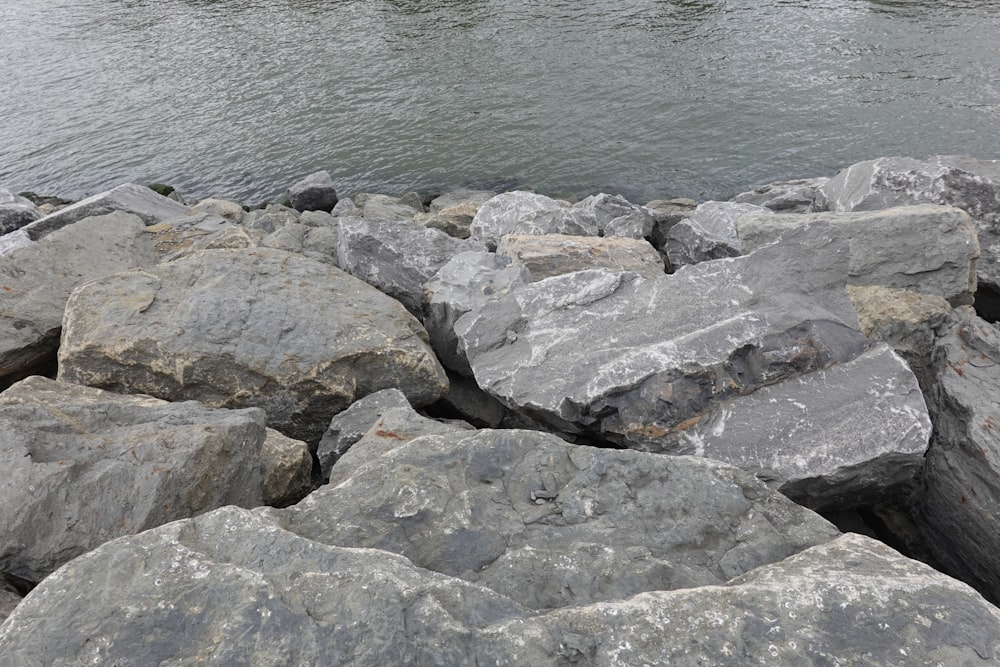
[{"left": 455, "top": 237, "right": 867, "bottom": 447}]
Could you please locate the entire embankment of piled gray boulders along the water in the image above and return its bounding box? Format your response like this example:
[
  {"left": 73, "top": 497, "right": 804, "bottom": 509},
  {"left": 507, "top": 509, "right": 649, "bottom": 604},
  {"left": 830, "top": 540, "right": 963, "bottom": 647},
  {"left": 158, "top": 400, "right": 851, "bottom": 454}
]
[{"left": 0, "top": 157, "right": 1000, "bottom": 666}]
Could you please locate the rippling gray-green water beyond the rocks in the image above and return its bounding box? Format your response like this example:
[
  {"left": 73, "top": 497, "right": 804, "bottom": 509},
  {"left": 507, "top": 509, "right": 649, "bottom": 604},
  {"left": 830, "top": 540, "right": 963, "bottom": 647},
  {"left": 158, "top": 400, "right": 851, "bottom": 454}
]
[{"left": 0, "top": 0, "right": 1000, "bottom": 201}]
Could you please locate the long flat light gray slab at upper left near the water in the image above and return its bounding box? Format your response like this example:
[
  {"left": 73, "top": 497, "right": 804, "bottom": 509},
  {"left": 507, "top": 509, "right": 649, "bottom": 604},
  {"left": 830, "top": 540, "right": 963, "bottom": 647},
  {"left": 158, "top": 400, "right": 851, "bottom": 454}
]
[{"left": 19, "top": 183, "right": 188, "bottom": 241}]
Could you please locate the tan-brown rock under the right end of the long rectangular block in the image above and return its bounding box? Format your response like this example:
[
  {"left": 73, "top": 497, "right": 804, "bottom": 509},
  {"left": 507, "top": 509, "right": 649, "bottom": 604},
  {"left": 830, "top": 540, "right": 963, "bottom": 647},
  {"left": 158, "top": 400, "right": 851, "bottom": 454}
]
[{"left": 847, "top": 285, "right": 951, "bottom": 392}]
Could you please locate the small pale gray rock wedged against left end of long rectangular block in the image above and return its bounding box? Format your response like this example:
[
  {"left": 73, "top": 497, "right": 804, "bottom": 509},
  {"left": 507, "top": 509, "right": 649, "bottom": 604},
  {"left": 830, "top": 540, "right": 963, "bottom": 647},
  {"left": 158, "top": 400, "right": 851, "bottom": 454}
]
[{"left": 663, "top": 201, "right": 767, "bottom": 269}]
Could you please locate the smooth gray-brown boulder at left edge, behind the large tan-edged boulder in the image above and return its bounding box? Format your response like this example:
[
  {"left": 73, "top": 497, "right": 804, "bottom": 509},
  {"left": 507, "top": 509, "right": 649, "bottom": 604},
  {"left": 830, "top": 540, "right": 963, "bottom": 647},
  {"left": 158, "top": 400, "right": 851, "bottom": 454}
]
[{"left": 0, "top": 214, "right": 158, "bottom": 388}]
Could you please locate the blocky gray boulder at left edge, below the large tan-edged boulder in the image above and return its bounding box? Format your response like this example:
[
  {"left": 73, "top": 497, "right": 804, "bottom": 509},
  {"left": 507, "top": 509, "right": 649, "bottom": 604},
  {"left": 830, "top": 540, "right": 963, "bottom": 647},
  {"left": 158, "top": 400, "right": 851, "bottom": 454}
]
[{"left": 0, "top": 377, "right": 264, "bottom": 581}]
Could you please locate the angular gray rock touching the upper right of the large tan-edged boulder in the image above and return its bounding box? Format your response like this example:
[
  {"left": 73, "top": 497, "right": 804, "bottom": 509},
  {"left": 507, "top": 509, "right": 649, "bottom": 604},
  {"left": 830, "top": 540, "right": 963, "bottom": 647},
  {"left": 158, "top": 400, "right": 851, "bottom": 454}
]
[{"left": 338, "top": 217, "right": 483, "bottom": 314}]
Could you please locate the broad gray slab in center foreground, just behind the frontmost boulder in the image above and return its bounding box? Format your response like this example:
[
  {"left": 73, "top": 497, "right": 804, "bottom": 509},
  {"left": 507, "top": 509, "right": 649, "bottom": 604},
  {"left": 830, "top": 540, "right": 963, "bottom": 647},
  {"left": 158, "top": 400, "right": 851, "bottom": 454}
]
[{"left": 275, "top": 430, "right": 838, "bottom": 609}]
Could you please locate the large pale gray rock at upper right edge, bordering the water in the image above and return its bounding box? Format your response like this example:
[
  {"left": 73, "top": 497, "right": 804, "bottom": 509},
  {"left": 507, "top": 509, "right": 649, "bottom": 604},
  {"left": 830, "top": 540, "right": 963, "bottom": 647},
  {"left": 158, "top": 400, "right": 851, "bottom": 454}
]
[{"left": 816, "top": 155, "right": 1000, "bottom": 291}]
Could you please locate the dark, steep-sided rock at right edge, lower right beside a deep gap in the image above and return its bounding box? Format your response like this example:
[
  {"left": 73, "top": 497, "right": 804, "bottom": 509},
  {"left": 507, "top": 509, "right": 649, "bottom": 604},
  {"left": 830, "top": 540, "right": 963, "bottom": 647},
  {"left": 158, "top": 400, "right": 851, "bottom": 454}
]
[{"left": 917, "top": 308, "right": 1000, "bottom": 603}]
